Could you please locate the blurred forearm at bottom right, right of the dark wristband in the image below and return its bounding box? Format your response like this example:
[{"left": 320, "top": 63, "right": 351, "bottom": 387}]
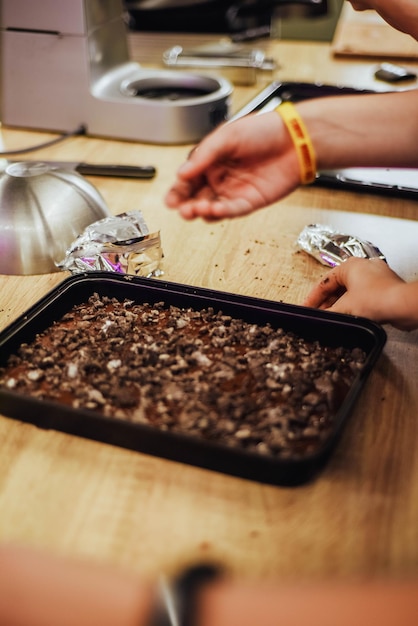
[{"left": 197, "top": 582, "right": 418, "bottom": 626}]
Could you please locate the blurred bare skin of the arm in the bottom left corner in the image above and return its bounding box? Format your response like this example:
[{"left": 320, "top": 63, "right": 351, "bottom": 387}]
[{"left": 0, "top": 546, "right": 155, "bottom": 626}]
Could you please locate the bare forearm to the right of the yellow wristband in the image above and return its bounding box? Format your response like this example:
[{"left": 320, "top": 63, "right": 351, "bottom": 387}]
[{"left": 297, "top": 89, "right": 418, "bottom": 169}]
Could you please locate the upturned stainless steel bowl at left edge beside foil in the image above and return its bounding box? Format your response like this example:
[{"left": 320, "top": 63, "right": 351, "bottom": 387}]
[{"left": 0, "top": 162, "right": 110, "bottom": 274}]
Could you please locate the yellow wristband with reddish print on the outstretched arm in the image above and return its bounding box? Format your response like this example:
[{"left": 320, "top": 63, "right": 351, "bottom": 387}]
[{"left": 276, "top": 102, "right": 316, "bottom": 185}]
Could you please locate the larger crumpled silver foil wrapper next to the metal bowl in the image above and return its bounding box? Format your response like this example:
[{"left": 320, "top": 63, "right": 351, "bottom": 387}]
[{"left": 58, "top": 211, "right": 163, "bottom": 278}]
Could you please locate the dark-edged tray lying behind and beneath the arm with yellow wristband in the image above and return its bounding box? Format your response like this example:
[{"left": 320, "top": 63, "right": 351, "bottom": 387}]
[{"left": 233, "top": 81, "right": 418, "bottom": 200}]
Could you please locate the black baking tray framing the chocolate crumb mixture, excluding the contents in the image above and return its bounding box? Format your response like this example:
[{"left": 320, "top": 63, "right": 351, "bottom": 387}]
[{"left": 0, "top": 272, "right": 386, "bottom": 486}]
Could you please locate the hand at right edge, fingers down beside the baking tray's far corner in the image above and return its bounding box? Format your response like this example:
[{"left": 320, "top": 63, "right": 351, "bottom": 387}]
[{"left": 303, "top": 257, "right": 418, "bottom": 330}]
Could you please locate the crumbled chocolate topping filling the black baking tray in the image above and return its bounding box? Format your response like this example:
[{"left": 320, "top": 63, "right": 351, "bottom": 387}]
[{"left": 0, "top": 294, "right": 365, "bottom": 458}]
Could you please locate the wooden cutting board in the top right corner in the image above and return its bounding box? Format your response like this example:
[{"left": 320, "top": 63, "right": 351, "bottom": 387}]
[{"left": 331, "top": 4, "right": 418, "bottom": 60}]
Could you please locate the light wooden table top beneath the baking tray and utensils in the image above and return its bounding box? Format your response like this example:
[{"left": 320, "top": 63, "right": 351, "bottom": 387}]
[{"left": 0, "top": 34, "right": 418, "bottom": 580}]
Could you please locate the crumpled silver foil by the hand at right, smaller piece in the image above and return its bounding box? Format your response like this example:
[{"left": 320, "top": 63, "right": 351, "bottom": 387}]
[{"left": 297, "top": 224, "right": 386, "bottom": 267}]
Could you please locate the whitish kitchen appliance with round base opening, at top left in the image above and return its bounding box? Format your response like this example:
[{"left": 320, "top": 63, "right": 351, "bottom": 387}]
[{"left": 0, "top": 0, "right": 232, "bottom": 144}]
